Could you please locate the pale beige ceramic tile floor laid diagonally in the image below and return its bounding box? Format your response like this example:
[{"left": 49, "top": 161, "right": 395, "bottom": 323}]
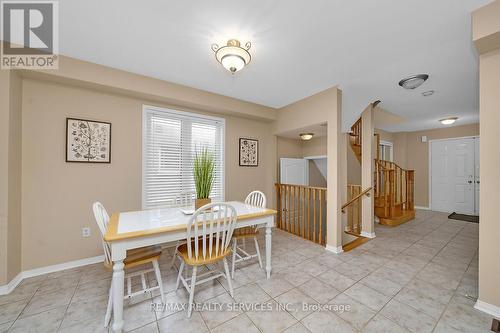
[{"left": 0, "top": 211, "right": 491, "bottom": 333}]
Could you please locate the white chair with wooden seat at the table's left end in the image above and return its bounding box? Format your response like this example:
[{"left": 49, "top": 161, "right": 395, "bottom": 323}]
[{"left": 93, "top": 202, "right": 165, "bottom": 327}]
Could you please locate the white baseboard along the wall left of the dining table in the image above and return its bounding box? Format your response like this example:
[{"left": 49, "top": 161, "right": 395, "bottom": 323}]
[{"left": 0, "top": 255, "right": 104, "bottom": 295}]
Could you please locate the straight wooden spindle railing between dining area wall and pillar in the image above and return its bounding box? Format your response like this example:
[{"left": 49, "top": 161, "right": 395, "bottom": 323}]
[{"left": 275, "top": 183, "right": 327, "bottom": 245}]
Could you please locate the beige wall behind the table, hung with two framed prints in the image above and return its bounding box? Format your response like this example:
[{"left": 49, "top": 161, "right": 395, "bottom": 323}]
[{"left": 20, "top": 80, "right": 276, "bottom": 270}]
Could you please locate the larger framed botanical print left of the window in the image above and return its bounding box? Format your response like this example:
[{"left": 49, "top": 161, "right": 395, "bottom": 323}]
[{"left": 66, "top": 118, "right": 111, "bottom": 163}]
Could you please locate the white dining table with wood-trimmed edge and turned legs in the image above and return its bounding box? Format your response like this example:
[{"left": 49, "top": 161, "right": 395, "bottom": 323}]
[{"left": 104, "top": 201, "right": 276, "bottom": 332}]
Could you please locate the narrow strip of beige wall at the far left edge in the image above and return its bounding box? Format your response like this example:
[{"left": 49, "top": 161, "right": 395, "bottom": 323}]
[{"left": 0, "top": 70, "right": 22, "bottom": 285}]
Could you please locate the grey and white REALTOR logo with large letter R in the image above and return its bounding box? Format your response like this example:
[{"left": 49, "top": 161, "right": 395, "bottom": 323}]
[{"left": 0, "top": 1, "right": 59, "bottom": 69}]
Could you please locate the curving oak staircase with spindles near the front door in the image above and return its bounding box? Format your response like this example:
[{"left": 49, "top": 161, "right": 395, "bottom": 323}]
[{"left": 349, "top": 118, "right": 415, "bottom": 226}]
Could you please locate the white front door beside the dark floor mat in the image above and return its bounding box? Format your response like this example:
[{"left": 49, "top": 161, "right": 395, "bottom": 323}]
[{"left": 431, "top": 138, "right": 475, "bottom": 214}]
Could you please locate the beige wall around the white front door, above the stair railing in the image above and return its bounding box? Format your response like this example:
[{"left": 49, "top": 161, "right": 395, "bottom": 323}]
[{"left": 394, "top": 124, "right": 479, "bottom": 207}]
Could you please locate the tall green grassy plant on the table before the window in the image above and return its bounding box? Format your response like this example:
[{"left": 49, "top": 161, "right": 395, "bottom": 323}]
[{"left": 193, "top": 148, "right": 215, "bottom": 199}]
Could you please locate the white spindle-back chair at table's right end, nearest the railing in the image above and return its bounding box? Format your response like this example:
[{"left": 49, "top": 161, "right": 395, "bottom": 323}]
[{"left": 231, "top": 191, "right": 266, "bottom": 278}]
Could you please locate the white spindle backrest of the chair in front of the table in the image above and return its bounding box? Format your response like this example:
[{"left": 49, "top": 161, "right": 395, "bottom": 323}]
[{"left": 186, "top": 202, "right": 237, "bottom": 260}]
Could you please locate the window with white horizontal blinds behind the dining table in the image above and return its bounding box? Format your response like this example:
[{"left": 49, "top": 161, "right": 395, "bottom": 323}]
[{"left": 142, "top": 106, "right": 225, "bottom": 209}]
